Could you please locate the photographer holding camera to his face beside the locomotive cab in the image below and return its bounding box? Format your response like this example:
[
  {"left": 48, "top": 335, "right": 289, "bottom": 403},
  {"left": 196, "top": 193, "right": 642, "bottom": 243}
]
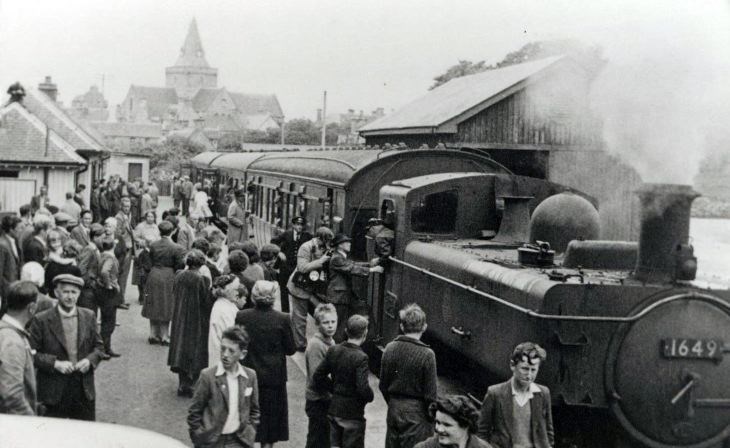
[{"left": 286, "top": 227, "right": 334, "bottom": 352}]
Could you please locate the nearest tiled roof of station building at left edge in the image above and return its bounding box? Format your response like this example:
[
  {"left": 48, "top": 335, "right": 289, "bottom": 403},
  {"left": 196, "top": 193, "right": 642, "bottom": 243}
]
[{"left": 0, "top": 102, "right": 86, "bottom": 166}]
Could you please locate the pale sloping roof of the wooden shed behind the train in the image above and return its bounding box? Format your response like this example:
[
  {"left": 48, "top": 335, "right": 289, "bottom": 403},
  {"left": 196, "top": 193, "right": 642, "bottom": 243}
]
[{"left": 359, "top": 56, "right": 563, "bottom": 135}]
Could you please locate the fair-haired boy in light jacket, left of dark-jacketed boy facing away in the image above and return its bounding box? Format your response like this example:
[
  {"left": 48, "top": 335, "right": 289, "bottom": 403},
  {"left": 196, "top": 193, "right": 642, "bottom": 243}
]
[{"left": 302, "top": 302, "right": 337, "bottom": 448}]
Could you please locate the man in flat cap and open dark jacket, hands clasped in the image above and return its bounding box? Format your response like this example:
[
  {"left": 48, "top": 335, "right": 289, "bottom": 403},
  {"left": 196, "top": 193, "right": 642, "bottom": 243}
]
[{"left": 29, "top": 274, "right": 103, "bottom": 421}]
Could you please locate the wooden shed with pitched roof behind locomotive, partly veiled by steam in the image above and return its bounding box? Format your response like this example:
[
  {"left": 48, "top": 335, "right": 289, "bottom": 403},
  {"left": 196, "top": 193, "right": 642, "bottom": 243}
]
[{"left": 359, "top": 56, "right": 641, "bottom": 239}]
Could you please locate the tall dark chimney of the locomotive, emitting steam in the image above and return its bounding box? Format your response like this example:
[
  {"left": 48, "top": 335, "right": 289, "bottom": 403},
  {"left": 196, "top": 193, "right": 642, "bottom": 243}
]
[{"left": 634, "top": 184, "right": 699, "bottom": 282}]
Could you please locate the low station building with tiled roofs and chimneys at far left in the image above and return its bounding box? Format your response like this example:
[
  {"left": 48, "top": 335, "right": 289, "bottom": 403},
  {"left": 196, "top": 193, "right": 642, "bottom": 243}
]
[{"left": 0, "top": 82, "right": 107, "bottom": 211}]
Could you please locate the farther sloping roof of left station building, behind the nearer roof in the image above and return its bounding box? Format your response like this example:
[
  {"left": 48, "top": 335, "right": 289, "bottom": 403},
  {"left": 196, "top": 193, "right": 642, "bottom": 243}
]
[{"left": 23, "top": 88, "right": 104, "bottom": 152}]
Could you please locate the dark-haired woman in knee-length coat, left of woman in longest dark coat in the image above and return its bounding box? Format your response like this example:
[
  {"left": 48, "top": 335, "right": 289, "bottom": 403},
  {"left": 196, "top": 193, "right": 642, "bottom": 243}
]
[{"left": 142, "top": 221, "right": 185, "bottom": 345}]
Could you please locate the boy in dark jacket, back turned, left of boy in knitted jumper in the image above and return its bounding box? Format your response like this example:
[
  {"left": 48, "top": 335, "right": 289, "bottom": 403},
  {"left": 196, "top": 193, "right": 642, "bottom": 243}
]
[{"left": 313, "top": 314, "right": 374, "bottom": 448}]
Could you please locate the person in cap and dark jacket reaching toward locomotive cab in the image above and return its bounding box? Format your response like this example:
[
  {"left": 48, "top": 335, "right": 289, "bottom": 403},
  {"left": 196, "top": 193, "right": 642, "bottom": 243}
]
[{"left": 327, "top": 233, "right": 383, "bottom": 342}]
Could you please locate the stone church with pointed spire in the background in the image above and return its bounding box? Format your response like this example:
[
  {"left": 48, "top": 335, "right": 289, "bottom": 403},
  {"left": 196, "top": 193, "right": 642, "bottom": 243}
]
[{"left": 116, "top": 19, "right": 284, "bottom": 136}]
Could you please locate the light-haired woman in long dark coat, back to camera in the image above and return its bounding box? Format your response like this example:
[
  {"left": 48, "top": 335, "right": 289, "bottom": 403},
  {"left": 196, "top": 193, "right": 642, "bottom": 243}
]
[{"left": 236, "top": 280, "right": 296, "bottom": 448}]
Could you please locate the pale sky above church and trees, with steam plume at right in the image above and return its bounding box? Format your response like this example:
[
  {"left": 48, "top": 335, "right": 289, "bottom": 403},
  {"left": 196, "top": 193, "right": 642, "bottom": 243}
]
[{"left": 0, "top": 0, "right": 730, "bottom": 181}]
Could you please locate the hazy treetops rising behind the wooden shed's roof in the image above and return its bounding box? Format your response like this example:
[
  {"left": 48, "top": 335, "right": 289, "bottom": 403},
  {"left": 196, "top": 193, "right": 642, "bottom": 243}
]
[{"left": 429, "top": 39, "right": 602, "bottom": 90}]
